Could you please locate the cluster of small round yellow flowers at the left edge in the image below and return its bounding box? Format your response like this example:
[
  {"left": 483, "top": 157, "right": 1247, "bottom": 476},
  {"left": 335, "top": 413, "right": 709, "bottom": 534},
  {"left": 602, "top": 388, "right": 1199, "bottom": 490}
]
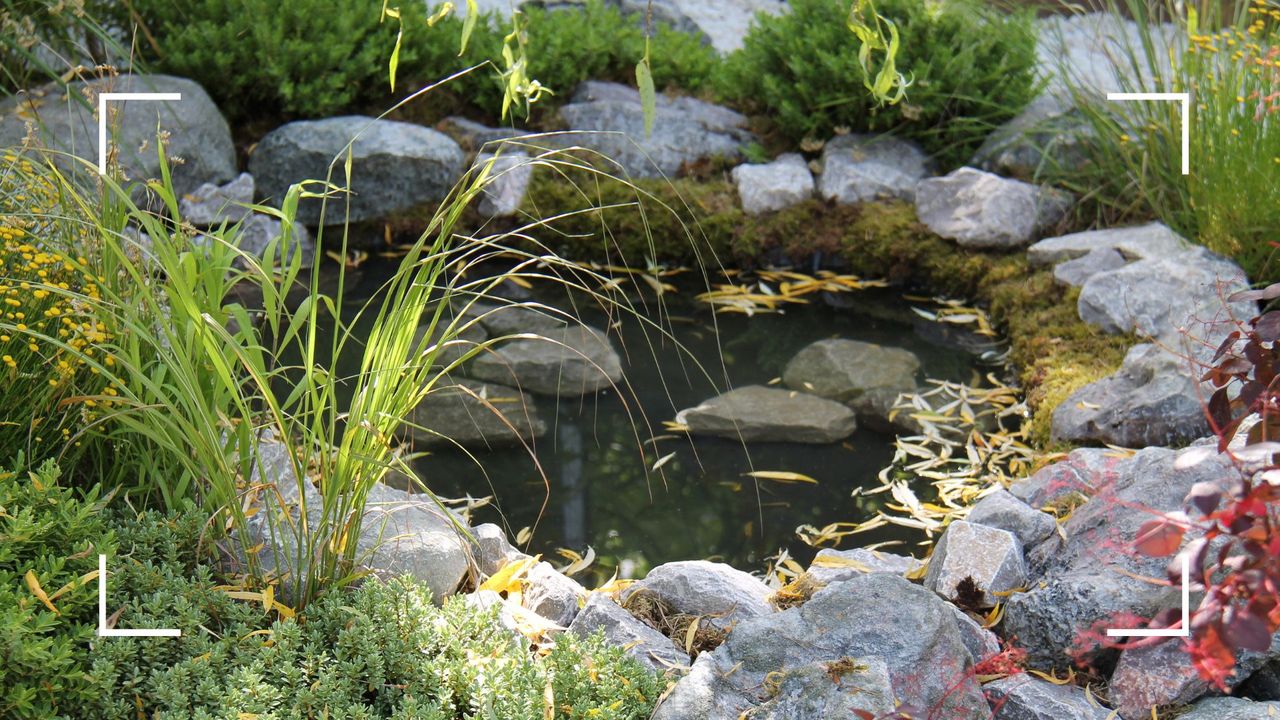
[{"left": 0, "top": 155, "right": 116, "bottom": 445}]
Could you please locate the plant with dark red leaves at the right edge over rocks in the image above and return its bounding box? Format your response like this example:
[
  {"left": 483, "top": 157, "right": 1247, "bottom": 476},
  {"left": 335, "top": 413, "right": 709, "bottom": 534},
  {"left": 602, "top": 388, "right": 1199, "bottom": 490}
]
[{"left": 1137, "top": 283, "right": 1280, "bottom": 689}]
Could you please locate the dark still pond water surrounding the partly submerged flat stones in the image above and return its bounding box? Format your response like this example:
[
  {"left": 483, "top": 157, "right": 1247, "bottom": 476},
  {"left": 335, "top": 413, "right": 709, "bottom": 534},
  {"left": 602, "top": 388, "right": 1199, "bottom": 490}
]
[{"left": 296, "top": 260, "right": 983, "bottom": 579}]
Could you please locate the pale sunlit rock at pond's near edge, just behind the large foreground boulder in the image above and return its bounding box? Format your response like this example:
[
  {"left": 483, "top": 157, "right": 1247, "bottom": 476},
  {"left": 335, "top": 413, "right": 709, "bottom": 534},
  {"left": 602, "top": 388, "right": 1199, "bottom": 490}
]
[{"left": 620, "top": 560, "right": 773, "bottom": 629}]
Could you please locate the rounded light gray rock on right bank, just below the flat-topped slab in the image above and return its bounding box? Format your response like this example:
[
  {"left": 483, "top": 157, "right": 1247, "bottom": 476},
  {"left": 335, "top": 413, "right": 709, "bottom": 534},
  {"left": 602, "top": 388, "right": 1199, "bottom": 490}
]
[{"left": 1078, "top": 247, "right": 1256, "bottom": 346}]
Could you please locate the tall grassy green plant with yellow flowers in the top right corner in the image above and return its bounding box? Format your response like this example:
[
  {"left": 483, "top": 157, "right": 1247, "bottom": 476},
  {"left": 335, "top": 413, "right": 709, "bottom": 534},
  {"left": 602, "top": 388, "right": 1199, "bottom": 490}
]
[{"left": 1051, "top": 0, "right": 1280, "bottom": 281}]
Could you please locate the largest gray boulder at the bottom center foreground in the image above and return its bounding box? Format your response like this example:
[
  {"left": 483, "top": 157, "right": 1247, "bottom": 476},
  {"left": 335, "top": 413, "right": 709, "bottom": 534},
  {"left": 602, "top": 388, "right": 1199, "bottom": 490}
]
[{"left": 654, "top": 573, "right": 991, "bottom": 720}]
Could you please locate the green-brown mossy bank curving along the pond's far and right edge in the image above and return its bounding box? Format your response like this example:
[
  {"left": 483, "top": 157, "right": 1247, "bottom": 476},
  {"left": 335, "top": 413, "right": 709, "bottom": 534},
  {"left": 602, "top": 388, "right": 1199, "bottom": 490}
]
[{"left": 525, "top": 173, "right": 1133, "bottom": 448}]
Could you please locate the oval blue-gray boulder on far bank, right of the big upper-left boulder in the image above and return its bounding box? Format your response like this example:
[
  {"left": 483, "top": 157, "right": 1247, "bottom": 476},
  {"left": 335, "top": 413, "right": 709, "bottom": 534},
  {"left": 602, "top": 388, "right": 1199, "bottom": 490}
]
[{"left": 248, "top": 115, "right": 463, "bottom": 225}]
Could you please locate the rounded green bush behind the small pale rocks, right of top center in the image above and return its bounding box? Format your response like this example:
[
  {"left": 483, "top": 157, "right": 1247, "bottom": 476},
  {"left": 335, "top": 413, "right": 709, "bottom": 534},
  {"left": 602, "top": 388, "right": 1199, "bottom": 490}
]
[{"left": 719, "top": 0, "right": 1036, "bottom": 167}]
